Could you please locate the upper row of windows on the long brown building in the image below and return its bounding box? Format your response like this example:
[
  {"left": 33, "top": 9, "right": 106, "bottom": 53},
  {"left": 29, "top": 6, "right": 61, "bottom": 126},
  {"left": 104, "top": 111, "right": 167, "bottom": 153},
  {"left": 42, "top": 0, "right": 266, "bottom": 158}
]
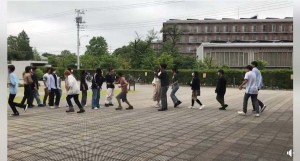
[{"left": 179, "top": 24, "right": 293, "bottom": 33}]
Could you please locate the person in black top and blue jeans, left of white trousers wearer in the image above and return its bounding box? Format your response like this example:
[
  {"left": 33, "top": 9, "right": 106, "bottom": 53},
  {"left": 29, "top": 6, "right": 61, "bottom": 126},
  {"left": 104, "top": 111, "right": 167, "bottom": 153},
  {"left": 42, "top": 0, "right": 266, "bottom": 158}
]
[{"left": 92, "top": 68, "right": 105, "bottom": 110}]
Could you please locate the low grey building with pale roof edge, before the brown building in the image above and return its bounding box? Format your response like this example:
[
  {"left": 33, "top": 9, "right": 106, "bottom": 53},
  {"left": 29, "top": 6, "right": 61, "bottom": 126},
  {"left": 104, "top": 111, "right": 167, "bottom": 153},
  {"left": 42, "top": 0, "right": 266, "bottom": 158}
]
[{"left": 196, "top": 42, "right": 293, "bottom": 68}]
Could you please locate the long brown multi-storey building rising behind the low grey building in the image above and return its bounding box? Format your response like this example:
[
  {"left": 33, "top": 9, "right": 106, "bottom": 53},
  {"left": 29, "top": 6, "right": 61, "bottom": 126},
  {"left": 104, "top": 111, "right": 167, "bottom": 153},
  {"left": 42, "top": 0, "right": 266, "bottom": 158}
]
[{"left": 156, "top": 17, "right": 293, "bottom": 55}]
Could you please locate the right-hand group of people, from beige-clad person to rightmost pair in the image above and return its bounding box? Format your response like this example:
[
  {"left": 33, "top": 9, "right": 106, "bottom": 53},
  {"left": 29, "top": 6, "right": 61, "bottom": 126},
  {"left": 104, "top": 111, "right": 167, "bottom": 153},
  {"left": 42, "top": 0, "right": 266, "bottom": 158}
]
[{"left": 152, "top": 61, "right": 267, "bottom": 117}]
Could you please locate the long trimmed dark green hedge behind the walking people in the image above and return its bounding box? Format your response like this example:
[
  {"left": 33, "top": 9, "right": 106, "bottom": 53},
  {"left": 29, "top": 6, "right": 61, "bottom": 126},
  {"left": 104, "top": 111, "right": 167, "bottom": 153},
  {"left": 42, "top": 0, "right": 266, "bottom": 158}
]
[{"left": 37, "top": 68, "right": 293, "bottom": 89}]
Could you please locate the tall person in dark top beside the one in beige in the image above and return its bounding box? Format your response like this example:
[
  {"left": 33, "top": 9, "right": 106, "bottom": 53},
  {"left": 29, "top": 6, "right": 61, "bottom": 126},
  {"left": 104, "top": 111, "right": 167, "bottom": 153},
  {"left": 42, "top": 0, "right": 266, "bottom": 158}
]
[{"left": 158, "top": 64, "right": 169, "bottom": 111}]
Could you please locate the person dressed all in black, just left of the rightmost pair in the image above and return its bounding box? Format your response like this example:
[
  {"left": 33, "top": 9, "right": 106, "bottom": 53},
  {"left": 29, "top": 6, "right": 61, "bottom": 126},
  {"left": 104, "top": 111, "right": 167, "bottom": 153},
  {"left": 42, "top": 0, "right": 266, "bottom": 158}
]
[{"left": 215, "top": 69, "right": 228, "bottom": 110}]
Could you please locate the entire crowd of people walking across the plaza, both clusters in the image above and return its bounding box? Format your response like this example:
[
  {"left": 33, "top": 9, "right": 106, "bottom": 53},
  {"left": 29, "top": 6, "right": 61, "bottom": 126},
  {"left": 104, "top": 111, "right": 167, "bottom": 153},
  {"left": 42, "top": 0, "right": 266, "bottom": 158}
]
[{"left": 8, "top": 61, "right": 266, "bottom": 117}]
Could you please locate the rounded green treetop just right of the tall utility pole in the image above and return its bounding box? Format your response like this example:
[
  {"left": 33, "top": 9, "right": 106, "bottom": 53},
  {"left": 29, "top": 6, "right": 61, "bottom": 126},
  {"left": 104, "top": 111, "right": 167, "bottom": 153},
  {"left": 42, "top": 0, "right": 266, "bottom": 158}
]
[{"left": 85, "top": 36, "right": 109, "bottom": 56}]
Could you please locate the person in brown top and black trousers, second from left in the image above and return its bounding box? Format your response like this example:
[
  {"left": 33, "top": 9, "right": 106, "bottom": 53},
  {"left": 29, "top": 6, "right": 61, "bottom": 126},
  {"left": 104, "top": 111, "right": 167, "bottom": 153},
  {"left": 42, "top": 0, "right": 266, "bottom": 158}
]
[{"left": 21, "top": 66, "right": 34, "bottom": 108}]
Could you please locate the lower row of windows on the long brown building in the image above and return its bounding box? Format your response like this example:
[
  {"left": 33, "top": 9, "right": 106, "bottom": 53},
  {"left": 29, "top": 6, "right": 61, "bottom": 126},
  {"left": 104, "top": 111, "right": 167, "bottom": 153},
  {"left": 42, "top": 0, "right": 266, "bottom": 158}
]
[{"left": 180, "top": 35, "right": 293, "bottom": 43}]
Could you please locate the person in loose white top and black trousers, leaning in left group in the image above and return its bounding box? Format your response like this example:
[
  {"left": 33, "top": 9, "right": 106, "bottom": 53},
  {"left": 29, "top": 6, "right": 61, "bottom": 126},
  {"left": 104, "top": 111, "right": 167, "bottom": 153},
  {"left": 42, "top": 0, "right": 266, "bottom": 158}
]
[{"left": 64, "top": 70, "right": 85, "bottom": 113}]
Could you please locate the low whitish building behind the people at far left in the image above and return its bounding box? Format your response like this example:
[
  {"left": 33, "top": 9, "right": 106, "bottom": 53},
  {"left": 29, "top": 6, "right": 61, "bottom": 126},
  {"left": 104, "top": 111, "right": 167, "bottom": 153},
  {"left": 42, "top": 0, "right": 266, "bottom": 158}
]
[{"left": 11, "top": 61, "right": 51, "bottom": 79}]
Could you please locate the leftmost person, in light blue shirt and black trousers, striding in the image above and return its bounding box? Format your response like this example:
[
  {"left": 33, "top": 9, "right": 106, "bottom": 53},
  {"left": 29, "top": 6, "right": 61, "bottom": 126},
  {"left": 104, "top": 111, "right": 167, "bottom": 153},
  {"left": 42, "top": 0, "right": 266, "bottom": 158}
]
[{"left": 8, "top": 65, "right": 28, "bottom": 116}]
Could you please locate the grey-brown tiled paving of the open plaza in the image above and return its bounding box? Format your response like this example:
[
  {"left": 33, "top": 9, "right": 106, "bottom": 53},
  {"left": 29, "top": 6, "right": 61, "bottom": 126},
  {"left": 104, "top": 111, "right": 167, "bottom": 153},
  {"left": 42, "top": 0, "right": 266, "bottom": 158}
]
[{"left": 8, "top": 86, "right": 293, "bottom": 161}]
